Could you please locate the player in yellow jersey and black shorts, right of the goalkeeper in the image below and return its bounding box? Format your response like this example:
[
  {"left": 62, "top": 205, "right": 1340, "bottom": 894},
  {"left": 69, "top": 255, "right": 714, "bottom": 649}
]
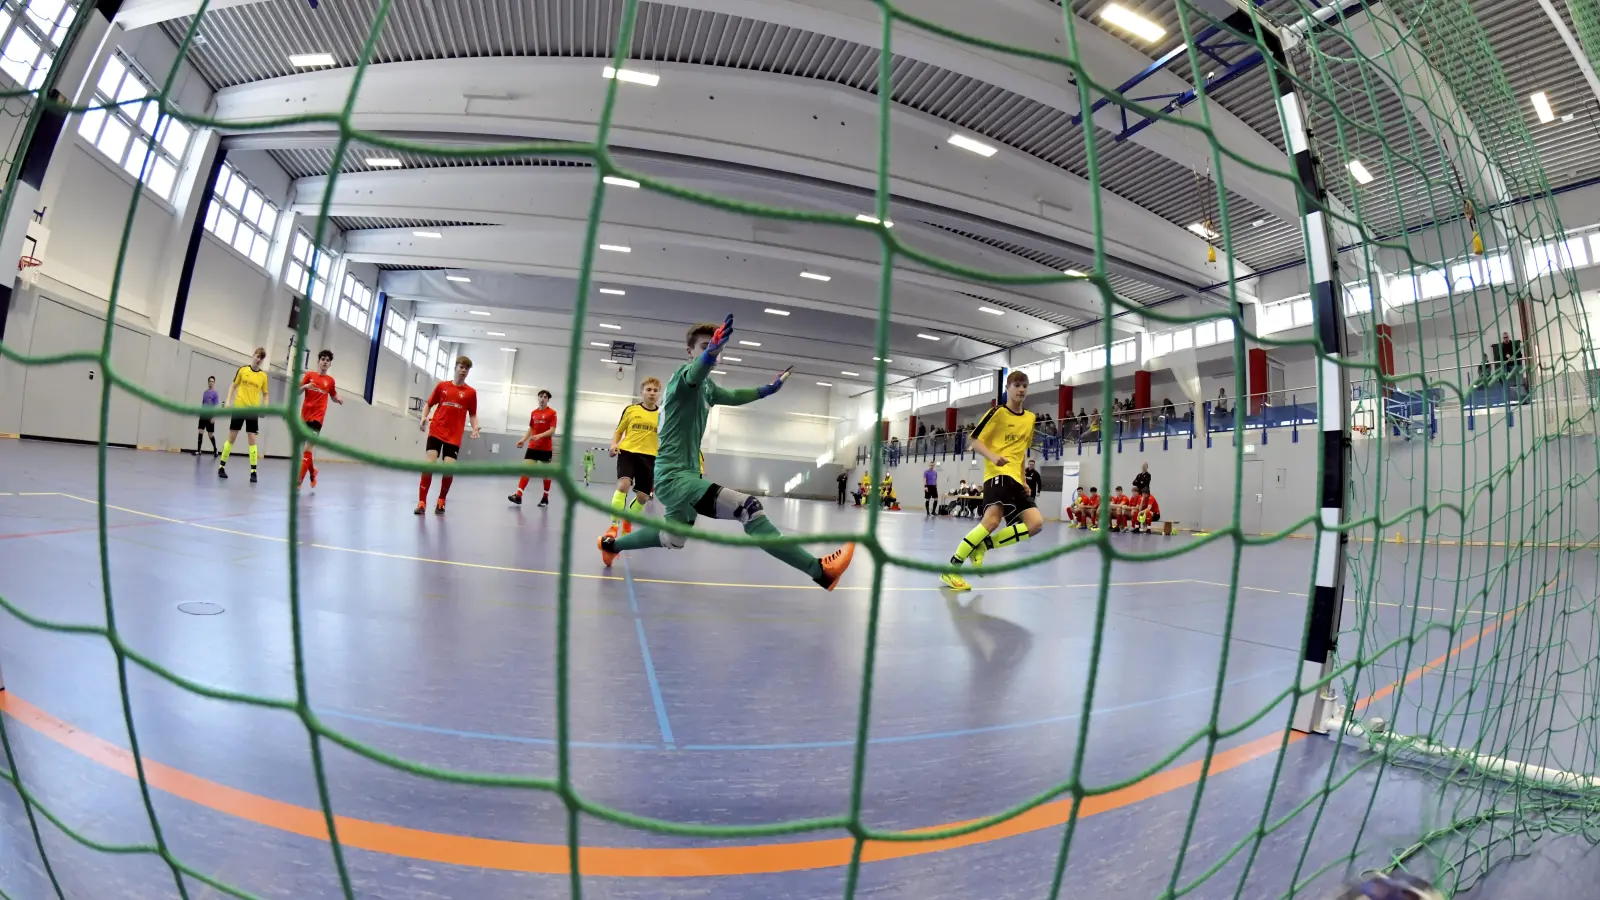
[{"left": 939, "top": 372, "right": 1045, "bottom": 591}]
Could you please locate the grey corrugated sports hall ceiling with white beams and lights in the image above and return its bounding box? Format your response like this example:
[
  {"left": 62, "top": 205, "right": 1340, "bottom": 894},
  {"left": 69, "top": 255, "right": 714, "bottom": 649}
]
[{"left": 125, "top": 0, "right": 1600, "bottom": 376}]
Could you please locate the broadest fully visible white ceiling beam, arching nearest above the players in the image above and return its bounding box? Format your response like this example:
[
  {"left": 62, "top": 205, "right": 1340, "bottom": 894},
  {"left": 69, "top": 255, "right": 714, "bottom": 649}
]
[{"left": 216, "top": 58, "right": 1250, "bottom": 283}]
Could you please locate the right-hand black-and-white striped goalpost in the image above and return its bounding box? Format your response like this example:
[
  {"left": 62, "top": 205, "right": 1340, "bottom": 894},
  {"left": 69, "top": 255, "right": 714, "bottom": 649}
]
[{"left": 1266, "top": 32, "right": 1350, "bottom": 733}]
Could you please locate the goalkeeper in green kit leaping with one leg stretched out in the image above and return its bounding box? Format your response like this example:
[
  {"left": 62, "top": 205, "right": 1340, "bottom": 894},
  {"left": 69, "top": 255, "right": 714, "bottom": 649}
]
[{"left": 600, "top": 315, "right": 856, "bottom": 591}]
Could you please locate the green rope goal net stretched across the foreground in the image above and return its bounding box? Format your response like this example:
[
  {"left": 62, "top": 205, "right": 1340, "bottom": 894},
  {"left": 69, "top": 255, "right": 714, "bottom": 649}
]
[{"left": 0, "top": 0, "right": 1600, "bottom": 898}]
